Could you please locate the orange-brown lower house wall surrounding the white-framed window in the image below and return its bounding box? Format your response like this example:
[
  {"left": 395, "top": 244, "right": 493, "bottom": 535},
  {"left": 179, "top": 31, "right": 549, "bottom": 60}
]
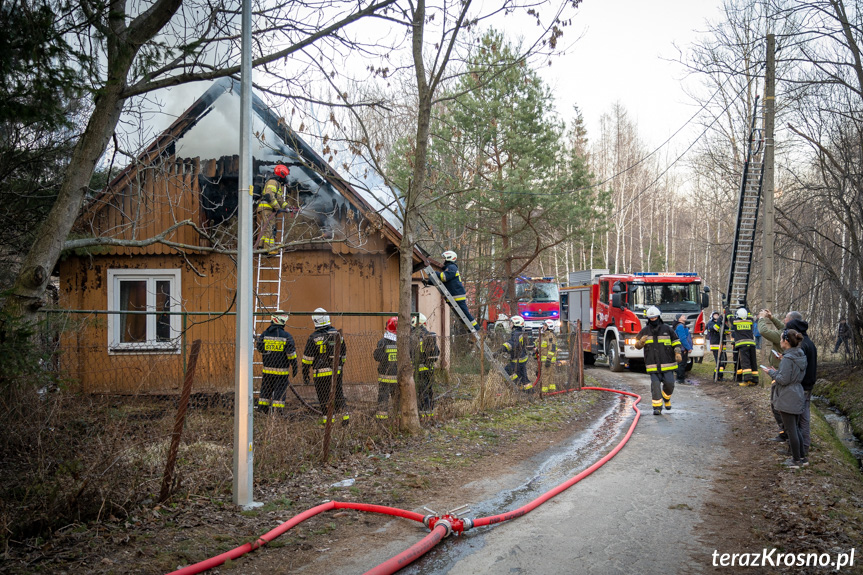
[{"left": 60, "top": 241, "right": 412, "bottom": 394}]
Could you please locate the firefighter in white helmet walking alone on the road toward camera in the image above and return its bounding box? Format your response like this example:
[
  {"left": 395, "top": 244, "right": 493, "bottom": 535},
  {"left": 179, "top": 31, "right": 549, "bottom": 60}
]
[{"left": 635, "top": 306, "right": 683, "bottom": 415}]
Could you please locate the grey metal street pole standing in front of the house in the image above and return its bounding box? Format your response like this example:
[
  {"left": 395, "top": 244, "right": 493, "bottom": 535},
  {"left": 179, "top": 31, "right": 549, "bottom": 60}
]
[{"left": 233, "top": 0, "right": 255, "bottom": 507}]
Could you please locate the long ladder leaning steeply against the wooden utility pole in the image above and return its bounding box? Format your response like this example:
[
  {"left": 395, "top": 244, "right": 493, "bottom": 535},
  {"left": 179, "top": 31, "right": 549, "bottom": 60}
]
[{"left": 719, "top": 96, "right": 764, "bottom": 380}]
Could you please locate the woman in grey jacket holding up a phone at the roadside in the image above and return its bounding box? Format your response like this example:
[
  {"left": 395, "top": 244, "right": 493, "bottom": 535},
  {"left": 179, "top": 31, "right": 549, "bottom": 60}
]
[{"left": 761, "top": 329, "right": 809, "bottom": 469}]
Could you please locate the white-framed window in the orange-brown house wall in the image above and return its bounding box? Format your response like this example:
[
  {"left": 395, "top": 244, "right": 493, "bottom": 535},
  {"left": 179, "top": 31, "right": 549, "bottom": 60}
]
[{"left": 108, "top": 269, "right": 182, "bottom": 353}]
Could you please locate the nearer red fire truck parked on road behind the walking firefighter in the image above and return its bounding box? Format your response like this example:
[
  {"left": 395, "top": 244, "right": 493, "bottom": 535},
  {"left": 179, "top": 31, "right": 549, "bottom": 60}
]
[{"left": 560, "top": 269, "right": 710, "bottom": 371}]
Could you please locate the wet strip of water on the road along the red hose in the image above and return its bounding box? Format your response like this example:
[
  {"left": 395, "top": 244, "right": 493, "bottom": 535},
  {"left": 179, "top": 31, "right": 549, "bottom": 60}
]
[{"left": 400, "top": 390, "right": 635, "bottom": 575}]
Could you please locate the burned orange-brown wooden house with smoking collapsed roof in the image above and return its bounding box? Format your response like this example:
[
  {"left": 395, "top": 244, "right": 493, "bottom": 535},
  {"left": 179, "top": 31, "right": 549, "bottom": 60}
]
[{"left": 59, "top": 79, "right": 449, "bottom": 393}]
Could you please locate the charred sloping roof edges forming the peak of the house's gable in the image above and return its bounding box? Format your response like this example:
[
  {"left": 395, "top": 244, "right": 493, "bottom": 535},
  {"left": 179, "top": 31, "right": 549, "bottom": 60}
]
[{"left": 75, "top": 76, "right": 431, "bottom": 265}]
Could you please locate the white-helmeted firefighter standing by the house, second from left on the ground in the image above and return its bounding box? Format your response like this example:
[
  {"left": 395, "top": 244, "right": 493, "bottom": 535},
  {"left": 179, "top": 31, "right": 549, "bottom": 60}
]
[{"left": 303, "top": 307, "right": 350, "bottom": 423}]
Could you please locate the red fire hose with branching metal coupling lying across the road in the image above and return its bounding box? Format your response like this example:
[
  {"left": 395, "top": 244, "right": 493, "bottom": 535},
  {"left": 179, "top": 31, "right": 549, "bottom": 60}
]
[{"left": 169, "top": 387, "right": 641, "bottom": 575}]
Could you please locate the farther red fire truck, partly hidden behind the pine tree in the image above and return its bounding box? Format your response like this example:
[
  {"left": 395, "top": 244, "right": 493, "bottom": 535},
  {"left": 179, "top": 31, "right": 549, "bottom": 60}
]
[{"left": 483, "top": 276, "right": 560, "bottom": 331}]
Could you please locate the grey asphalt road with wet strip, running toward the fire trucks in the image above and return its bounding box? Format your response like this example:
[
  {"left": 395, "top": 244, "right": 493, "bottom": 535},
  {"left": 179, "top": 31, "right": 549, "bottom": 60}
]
[{"left": 298, "top": 368, "right": 727, "bottom": 575}]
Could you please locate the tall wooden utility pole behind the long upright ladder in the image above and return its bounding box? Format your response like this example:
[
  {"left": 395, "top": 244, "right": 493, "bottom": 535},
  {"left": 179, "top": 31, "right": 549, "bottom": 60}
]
[{"left": 761, "top": 34, "right": 776, "bottom": 320}]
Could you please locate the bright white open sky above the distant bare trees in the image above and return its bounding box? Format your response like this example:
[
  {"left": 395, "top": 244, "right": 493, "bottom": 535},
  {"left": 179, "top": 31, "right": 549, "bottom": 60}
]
[{"left": 543, "top": 0, "right": 720, "bottom": 148}]
